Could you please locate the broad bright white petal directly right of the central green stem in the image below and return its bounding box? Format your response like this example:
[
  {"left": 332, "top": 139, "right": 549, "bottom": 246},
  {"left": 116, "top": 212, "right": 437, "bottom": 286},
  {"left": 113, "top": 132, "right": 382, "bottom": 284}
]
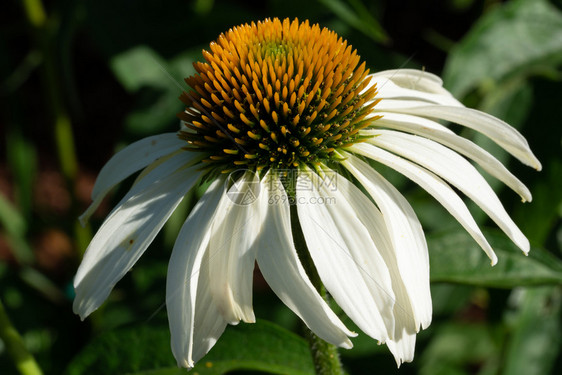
[{"left": 296, "top": 170, "right": 394, "bottom": 341}]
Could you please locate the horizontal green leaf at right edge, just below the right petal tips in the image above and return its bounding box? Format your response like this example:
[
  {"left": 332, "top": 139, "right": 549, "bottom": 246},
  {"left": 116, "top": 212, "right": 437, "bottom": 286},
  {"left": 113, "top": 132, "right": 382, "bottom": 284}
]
[{"left": 428, "top": 231, "right": 562, "bottom": 288}]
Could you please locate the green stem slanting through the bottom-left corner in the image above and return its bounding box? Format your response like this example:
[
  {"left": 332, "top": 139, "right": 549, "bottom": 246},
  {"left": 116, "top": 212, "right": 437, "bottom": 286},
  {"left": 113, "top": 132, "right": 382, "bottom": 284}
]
[{"left": 0, "top": 301, "right": 43, "bottom": 375}]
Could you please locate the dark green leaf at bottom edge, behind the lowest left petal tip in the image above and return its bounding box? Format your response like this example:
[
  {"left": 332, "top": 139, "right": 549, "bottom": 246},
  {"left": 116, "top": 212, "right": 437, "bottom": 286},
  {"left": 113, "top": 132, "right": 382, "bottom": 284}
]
[{"left": 66, "top": 321, "right": 314, "bottom": 375}]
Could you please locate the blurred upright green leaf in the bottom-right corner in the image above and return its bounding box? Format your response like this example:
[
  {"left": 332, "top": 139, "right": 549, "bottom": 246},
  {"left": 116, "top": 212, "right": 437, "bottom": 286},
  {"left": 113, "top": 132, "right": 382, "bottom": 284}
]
[{"left": 502, "top": 287, "right": 562, "bottom": 375}]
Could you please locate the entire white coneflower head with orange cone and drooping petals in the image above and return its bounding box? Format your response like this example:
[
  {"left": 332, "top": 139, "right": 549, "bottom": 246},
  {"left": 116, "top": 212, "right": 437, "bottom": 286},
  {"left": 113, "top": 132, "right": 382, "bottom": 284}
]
[{"left": 74, "top": 19, "right": 541, "bottom": 367}]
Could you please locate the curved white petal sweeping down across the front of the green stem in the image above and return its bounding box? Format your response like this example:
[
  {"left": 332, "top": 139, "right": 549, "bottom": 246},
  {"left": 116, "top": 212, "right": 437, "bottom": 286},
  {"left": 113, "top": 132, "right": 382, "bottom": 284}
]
[{"left": 256, "top": 172, "right": 356, "bottom": 349}]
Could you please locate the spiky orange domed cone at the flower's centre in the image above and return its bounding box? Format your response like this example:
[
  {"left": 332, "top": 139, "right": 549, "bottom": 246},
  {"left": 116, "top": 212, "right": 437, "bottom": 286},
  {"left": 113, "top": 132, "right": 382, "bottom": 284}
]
[{"left": 175, "top": 19, "right": 376, "bottom": 172}]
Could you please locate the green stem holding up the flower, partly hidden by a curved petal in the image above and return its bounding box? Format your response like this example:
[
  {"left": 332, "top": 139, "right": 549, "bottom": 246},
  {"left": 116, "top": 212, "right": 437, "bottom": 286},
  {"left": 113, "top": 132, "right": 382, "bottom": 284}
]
[{"left": 288, "top": 181, "right": 345, "bottom": 375}]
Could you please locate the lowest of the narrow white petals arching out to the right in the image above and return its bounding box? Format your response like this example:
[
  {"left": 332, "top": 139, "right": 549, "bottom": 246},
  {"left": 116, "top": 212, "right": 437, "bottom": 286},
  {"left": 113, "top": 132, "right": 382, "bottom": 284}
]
[{"left": 349, "top": 143, "right": 498, "bottom": 265}]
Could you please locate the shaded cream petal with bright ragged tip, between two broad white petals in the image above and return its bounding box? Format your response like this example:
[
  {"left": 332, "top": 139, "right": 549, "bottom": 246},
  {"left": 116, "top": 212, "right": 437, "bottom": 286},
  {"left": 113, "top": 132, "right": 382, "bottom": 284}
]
[{"left": 330, "top": 173, "right": 418, "bottom": 366}]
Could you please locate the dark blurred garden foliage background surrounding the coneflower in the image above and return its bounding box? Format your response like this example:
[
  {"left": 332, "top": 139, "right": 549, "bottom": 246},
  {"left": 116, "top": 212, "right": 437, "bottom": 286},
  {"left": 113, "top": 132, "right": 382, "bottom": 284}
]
[{"left": 0, "top": 0, "right": 562, "bottom": 375}]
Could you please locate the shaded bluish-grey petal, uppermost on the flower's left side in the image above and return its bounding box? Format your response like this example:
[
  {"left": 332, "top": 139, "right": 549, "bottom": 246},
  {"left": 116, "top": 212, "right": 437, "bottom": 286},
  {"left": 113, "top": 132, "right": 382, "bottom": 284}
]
[{"left": 80, "top": 133, "right": 185, "bottom": 223}]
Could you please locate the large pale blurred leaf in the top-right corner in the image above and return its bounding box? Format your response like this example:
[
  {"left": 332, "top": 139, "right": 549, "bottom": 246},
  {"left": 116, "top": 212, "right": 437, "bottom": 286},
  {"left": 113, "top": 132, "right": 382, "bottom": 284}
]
[{"left": 443, "top": 0, "right": 562, "bottom": 96}]
